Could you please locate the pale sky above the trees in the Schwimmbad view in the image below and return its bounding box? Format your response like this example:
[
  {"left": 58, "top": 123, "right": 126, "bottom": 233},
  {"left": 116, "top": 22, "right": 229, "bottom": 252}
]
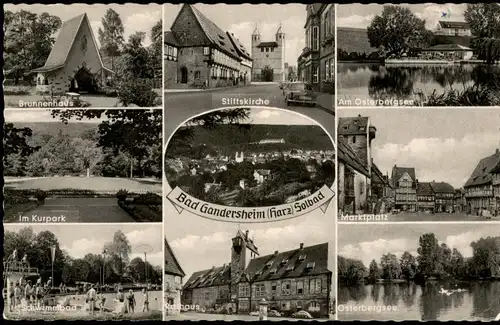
[{"left": 4, "top": 223, "right": 164, "bottom": 266}]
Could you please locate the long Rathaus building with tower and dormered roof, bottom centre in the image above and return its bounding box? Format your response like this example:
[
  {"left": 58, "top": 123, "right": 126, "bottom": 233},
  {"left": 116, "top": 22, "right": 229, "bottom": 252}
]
[{"left": 181, "top": 230, "right": 332, "bottom": 317}]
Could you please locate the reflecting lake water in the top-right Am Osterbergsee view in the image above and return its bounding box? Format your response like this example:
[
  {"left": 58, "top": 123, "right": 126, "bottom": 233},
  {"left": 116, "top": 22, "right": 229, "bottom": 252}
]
[{"left": 337, "top": 63, "right": 500, "bottom": 106}]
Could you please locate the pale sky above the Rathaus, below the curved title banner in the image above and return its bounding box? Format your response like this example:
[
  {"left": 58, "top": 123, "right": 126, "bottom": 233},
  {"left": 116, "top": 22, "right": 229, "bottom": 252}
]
[{"left": 164, "top": 200, "right": 336, "bottom": 281}]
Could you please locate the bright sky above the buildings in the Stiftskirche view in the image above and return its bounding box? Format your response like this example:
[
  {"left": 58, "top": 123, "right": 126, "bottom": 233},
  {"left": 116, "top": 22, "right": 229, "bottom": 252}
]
[{"left": 163, "top": 3, "right": 306, "bottom": 66}]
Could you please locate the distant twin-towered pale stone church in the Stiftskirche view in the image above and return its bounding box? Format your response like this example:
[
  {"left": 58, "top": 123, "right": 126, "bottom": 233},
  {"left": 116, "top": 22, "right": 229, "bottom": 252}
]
[{"left": 252, "top": 25, "right": 286, "bottom": 82}]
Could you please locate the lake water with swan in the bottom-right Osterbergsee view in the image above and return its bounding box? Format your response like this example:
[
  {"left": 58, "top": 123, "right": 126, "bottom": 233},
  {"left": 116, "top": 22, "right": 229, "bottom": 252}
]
[{"left": 338, "top": 281, "right": 500, "bottom": 321}]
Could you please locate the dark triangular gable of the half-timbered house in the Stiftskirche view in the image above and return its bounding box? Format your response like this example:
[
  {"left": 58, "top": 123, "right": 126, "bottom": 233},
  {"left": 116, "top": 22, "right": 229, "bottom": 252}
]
[{"left": 170, "top": 4, "right": 211, "bottom": 47}]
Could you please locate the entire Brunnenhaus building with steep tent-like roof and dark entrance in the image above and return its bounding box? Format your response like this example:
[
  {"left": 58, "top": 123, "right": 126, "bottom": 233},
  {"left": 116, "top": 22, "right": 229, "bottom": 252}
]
[{"left": 32, "top": 13, "right": 113, "bottom": 94}]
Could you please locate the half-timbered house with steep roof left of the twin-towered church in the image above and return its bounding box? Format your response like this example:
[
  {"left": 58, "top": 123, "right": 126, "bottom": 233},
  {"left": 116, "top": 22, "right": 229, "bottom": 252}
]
[{"left": 164, "top": 4, "right": 252, "bottom": 89}]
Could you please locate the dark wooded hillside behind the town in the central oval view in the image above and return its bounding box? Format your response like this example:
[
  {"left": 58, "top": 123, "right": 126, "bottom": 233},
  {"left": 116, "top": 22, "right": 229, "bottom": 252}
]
[{"left": 182, "top": 124, "right": 333, "bottom": 150}]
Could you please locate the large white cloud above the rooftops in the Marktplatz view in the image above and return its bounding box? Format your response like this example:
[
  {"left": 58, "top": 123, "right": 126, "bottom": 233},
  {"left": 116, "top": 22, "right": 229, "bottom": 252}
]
[{"left": 372, "top": 133, "right": 498, "bottom": 188}]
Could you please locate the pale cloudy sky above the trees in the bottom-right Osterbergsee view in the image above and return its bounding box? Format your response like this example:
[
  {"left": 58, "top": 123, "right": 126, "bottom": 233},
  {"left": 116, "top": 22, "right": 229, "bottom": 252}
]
[{"left": 338, "top": 223, "right": 500, "bottom": 267}]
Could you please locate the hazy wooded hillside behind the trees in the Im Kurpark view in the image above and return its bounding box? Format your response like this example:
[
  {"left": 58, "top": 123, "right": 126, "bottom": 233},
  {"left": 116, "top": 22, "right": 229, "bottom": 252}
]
[{"left": 14, "top": 119, "right": 98, "bottom": 137}]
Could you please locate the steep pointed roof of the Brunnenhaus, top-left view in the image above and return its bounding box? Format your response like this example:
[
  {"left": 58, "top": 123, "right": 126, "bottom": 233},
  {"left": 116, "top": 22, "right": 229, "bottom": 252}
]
[{"left": 33, "top": 13, "right": 111, "bottom": 72}]
